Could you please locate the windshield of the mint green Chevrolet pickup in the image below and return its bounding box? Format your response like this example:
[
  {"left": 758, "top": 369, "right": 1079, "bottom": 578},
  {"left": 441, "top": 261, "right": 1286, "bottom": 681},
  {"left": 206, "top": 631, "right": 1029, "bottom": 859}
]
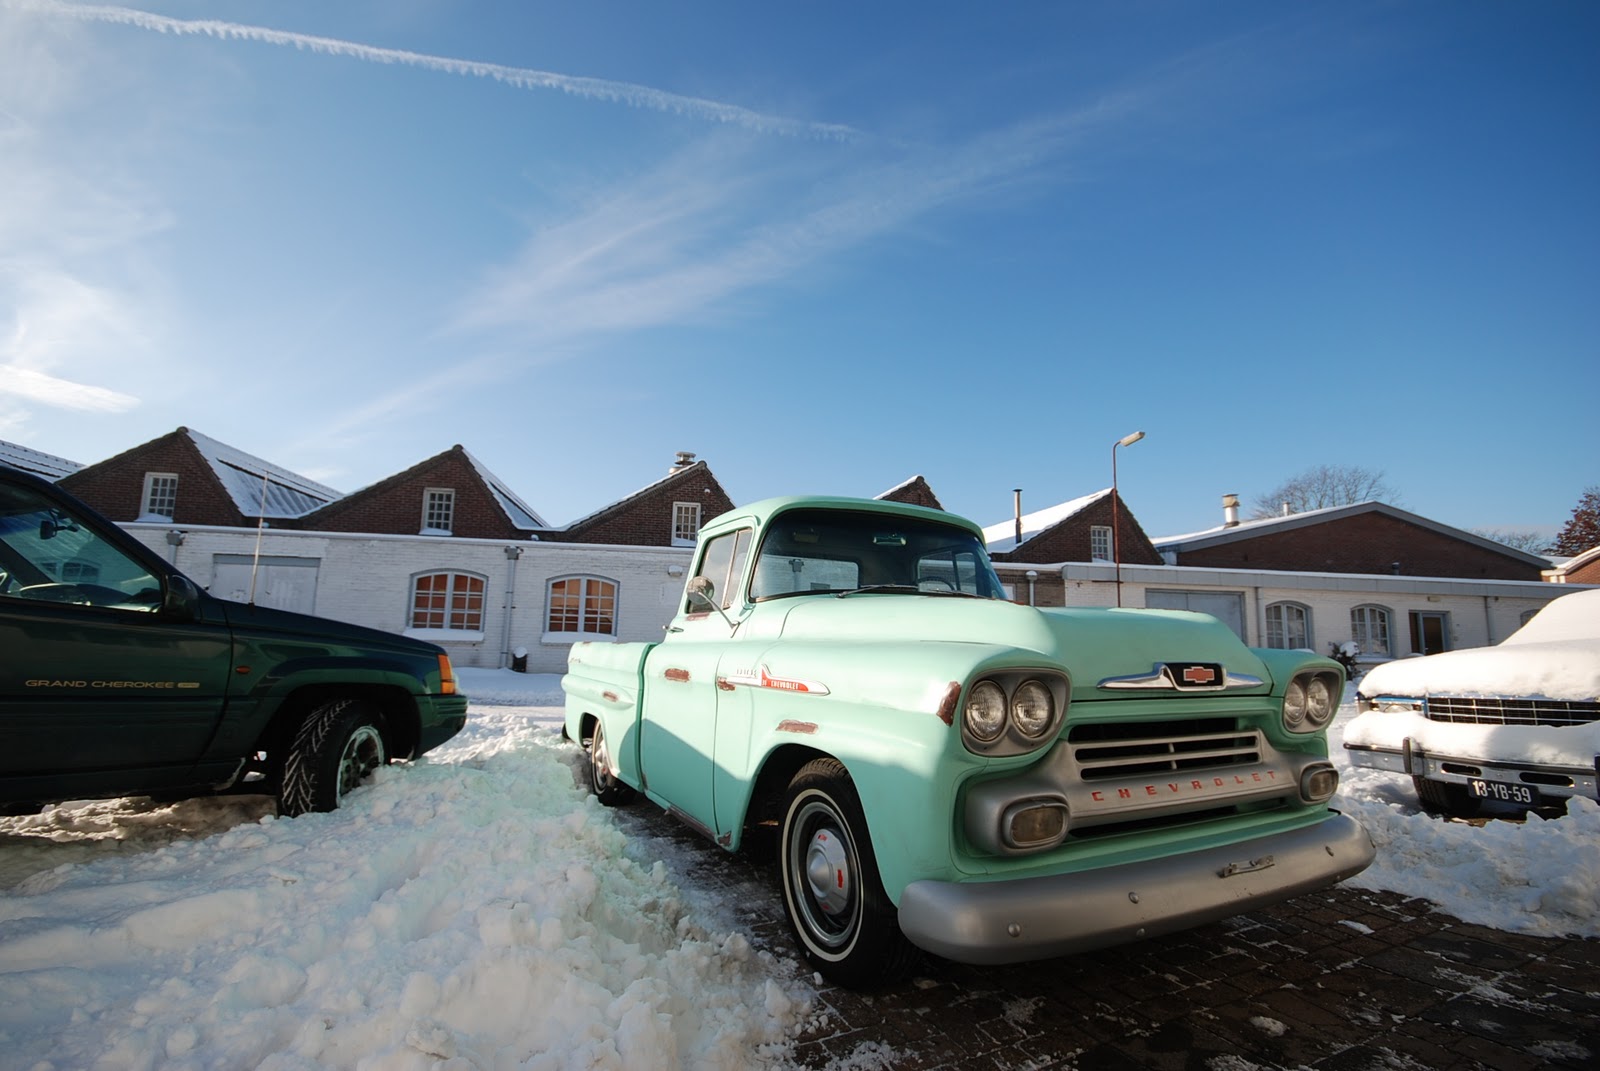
[{"left": 750, "top": 509, "right": 1005, "bottom": 600}]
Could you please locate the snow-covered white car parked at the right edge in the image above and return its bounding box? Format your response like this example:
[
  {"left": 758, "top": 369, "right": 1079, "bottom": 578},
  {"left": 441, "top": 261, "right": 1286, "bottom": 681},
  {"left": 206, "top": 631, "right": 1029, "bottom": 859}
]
[{"left": 1344, "top": 589, "right": 1600, "bottom": 818}]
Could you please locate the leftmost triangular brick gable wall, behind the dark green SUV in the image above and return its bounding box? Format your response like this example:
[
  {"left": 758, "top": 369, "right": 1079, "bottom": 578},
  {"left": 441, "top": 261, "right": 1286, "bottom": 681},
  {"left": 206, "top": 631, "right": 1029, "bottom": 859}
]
[{"left": 59, "top": 429, "right": 245, "bottom": 527}]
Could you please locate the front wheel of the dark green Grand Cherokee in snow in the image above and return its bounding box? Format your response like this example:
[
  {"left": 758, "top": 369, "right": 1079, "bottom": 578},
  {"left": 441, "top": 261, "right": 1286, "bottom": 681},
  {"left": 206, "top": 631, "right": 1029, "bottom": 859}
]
[{"left": 278, "top": 700, "right": 389, "bottom": 818}]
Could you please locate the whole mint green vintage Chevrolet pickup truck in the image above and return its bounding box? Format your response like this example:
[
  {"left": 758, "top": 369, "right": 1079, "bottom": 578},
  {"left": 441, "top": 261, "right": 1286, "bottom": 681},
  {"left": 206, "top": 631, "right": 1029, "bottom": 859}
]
[{"left": 562, "top": 498, "right": 1373, "bottom": 986}]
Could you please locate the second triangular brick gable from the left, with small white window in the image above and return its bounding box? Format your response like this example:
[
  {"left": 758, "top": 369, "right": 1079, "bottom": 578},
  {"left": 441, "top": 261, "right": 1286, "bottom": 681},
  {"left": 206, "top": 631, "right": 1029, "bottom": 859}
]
[{"left": 294, "top": 448, "right": 528, "bottom": 540}]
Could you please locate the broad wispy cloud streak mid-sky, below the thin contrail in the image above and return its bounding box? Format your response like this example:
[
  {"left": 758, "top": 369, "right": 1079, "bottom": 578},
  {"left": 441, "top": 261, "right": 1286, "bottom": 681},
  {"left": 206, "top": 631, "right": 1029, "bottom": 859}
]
[{"left": 453, "top": 98, "right": 1133, "bottom": 349}]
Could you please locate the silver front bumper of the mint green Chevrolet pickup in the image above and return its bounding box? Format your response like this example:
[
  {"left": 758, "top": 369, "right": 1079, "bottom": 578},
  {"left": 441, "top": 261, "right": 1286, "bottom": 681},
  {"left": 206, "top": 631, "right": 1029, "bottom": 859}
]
[{"left": 899, "top": 813, "right": 1374, "bottom": 964}]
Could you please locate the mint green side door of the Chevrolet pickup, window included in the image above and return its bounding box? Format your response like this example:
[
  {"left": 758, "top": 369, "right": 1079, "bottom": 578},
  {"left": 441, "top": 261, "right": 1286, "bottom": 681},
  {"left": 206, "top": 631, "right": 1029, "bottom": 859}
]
[{"left": 638, "top": 528, "right": 750, "bottom": 834}]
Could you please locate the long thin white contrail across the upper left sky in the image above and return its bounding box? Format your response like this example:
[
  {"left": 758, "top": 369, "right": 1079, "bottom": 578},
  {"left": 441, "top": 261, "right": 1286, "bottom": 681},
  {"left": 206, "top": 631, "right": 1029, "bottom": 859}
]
[{"left": 12, "top": 0, "right": 859, "bottom": 139}]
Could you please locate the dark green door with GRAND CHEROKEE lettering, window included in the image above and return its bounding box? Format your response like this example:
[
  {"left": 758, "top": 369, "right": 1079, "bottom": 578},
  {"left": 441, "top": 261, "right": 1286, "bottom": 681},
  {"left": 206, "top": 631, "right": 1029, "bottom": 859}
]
[{"left": 0, "top": 477, "right": 230, "bottom": 791}]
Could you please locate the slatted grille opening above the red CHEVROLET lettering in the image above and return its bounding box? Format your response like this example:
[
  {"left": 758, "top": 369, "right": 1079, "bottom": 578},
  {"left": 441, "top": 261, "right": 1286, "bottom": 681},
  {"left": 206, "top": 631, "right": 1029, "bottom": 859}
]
[{"left": 1067, "top": 717, "right": 1261, "bottom": 781}]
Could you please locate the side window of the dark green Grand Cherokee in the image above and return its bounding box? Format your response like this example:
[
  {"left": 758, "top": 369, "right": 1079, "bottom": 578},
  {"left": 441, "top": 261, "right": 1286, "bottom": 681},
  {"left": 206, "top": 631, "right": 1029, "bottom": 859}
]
[{"left": 0, "top": 485, "right": 162, "bottom": 612}]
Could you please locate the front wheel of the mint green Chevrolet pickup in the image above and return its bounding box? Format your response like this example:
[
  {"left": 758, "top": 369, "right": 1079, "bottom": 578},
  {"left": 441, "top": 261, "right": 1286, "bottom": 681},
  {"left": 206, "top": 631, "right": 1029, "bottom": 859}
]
[{"left": 778, "top": 759, "right": 915, "bottom": 988}]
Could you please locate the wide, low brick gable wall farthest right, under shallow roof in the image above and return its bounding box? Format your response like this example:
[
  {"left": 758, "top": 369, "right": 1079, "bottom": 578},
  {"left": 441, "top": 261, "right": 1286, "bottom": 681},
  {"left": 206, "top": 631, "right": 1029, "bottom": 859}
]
[{"left": 1178, "top": 514, "right": 1541, "bottom": 580}]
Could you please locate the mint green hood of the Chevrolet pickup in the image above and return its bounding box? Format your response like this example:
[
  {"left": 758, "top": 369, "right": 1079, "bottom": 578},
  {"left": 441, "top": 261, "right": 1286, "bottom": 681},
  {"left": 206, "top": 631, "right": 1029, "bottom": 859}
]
[{"left": 768, "top": 594, "right": 1272, "bottom": 688}]
